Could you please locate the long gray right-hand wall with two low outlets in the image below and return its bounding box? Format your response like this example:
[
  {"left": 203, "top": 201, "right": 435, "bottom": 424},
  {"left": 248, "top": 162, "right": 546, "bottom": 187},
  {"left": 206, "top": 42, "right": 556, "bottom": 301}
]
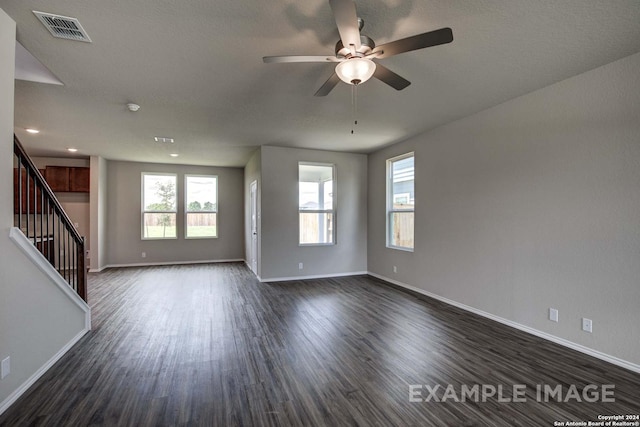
[{"left": 368, "top": 54, "right": 640, "bottom": 364}]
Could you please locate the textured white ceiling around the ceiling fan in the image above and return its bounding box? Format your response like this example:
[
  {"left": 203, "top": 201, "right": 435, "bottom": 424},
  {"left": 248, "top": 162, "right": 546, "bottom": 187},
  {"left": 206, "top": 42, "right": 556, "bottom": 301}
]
[{"left": 0, "top": 0, "right": 640, "bottom": 166}]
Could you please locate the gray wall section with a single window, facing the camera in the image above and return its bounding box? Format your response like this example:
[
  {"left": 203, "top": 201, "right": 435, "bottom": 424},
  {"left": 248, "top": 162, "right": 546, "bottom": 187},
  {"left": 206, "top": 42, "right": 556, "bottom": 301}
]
[{"left": 260, "top": 147, "right": 367, "bottom": 280}]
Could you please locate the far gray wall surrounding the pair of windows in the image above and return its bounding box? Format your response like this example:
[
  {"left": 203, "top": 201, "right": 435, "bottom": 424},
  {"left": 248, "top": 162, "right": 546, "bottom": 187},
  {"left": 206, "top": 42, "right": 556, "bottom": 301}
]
[{"left": 106, "top": 161, "right": 244, "bottom": 265}]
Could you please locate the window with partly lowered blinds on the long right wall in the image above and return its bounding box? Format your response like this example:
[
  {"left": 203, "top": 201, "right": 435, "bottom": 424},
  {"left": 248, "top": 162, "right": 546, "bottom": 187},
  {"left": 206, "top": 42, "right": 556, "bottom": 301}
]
[{"left": 387, "top": 153, "right": 415, "bottom": 250}]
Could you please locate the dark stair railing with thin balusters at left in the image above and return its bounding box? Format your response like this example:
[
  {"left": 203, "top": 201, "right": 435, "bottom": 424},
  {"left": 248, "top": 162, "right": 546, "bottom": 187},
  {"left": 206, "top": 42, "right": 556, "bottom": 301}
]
[{"left": 13, "top": 135, "right": 87, "bottom": 301}]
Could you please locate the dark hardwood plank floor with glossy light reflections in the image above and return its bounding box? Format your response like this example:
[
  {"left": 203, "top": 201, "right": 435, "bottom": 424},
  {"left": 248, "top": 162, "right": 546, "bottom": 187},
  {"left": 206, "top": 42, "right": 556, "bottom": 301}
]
[{"left": 0, "top": 264, "right": 640, "bottom": 427}]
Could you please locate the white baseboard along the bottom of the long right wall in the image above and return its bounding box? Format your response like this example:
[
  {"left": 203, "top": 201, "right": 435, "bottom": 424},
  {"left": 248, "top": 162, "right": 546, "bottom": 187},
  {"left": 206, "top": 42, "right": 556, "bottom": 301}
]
[{"left": 368, "top": 272, "right": 640, "bottom": 373}]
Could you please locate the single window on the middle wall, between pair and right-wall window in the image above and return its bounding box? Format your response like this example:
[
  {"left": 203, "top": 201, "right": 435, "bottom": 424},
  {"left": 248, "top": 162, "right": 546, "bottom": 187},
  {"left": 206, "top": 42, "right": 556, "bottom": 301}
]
[{"left": 298, "top": 163, "right": 336, "bottom": 245}]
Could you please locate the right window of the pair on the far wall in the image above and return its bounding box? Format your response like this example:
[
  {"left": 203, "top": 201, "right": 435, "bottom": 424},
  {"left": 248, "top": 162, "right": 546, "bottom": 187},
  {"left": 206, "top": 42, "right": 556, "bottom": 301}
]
[{"left": 185, "top": 175, "right": 218, "bottom": 239}]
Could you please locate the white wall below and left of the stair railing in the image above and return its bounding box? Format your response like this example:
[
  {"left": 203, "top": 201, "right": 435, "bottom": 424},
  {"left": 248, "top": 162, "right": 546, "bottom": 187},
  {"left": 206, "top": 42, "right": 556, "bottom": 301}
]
[{"left": 0, "top": 10, "right": 86, "bottom": 413}]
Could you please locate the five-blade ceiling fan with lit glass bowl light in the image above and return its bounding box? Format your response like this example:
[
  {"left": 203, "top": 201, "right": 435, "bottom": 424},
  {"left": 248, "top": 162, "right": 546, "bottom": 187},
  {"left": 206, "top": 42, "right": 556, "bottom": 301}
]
[{"left": 262, "top": 0, "right": 453, "bottom": 96}]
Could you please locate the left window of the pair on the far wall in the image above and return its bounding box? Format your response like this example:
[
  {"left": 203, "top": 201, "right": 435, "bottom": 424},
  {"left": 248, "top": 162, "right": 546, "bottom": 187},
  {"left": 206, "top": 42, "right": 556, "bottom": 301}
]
[{"left": 142, "top": 173, "right": 177, "bottom": 239}]
